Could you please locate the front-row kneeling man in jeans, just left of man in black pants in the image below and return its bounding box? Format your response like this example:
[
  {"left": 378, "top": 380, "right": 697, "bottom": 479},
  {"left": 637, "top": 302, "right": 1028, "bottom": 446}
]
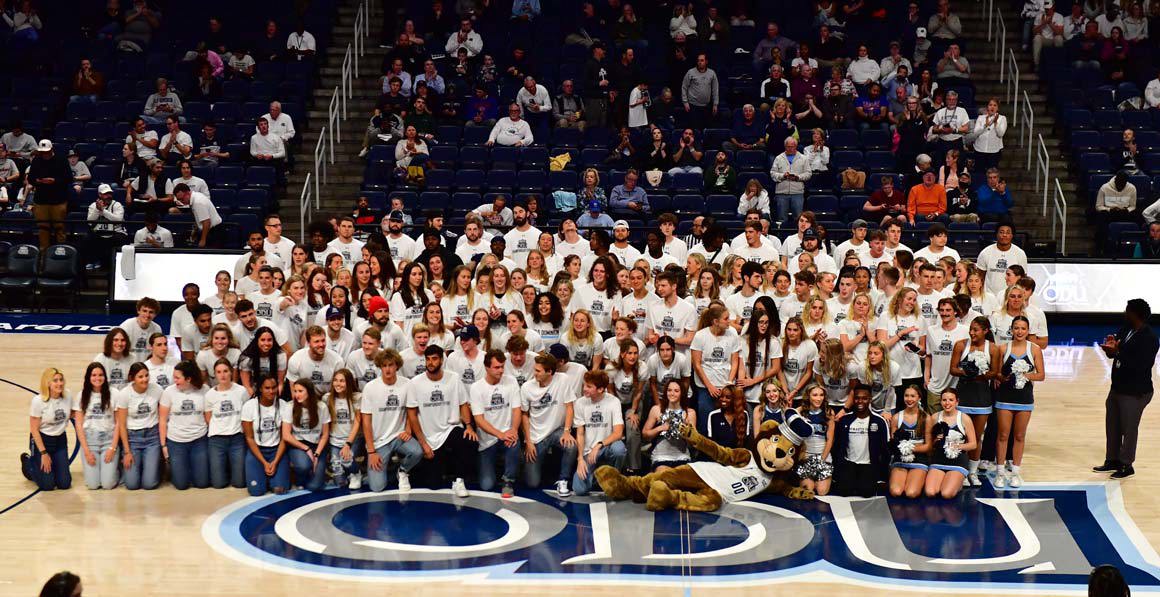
[{"left": 360, "top": 349, "right": 423, "bottom": 493}]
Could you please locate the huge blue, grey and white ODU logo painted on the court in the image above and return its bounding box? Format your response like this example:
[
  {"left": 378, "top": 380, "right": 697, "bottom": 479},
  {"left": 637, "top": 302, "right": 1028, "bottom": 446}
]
[{"left": 202, "top": 483, "right": 1160, "bottom": 595}]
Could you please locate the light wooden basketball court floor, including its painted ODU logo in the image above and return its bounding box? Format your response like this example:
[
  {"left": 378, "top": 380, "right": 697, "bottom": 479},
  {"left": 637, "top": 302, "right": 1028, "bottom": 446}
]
[{"left": 0, "top": 334, "right": 1160, "bottom": 597}]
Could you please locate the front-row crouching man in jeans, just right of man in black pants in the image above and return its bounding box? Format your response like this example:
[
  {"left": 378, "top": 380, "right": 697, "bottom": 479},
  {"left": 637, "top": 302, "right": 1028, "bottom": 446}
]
[{"left": 467, "top": 350, "right": 522, "bottom": 497}]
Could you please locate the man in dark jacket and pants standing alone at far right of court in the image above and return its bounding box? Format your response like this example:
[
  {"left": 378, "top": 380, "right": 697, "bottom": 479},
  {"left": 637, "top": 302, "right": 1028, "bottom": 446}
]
[{"left": 1092, "top": 299, "right": 1160, "bottom": 479}]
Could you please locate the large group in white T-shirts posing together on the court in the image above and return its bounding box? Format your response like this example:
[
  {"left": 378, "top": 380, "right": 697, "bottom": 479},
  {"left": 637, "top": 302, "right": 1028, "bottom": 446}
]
[{"left": 24, "top": 205, "right": 1046, "bottom": 495}]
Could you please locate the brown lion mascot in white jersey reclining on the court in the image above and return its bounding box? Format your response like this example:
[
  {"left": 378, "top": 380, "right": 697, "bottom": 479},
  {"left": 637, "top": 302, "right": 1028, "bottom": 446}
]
[{"left": 596, "top": 415, "right": 813, "bottom": 512}]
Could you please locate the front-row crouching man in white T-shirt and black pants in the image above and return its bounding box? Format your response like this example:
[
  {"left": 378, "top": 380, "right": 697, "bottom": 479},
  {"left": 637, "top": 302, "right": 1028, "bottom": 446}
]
[{"left": 405, "top": 344, "right": 479, "bottom": 497}]
